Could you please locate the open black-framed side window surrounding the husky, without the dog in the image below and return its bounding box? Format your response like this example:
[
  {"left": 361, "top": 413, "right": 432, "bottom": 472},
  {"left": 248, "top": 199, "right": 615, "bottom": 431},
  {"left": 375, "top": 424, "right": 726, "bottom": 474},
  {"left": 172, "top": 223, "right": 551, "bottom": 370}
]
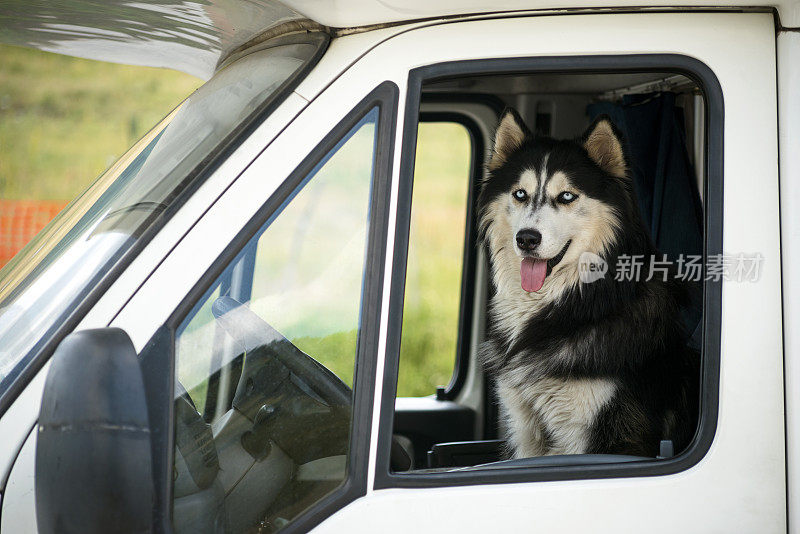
[{"left": 376, "top": 56, "right": 722, "bottom": 487}]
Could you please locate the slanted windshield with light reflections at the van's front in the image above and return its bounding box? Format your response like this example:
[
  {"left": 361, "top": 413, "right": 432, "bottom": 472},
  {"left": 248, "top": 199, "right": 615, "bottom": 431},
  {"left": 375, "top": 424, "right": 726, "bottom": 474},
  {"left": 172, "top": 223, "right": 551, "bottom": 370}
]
[{"left": 0, "top": 33, "right": 327, "bottom": 395}]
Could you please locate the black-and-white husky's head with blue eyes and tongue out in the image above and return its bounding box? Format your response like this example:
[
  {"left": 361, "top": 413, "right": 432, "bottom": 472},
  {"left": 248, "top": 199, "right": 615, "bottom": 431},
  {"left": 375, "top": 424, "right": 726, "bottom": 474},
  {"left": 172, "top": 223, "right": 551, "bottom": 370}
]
[{"left": 478, "top": 109, "right": 630, "bottom": 293}]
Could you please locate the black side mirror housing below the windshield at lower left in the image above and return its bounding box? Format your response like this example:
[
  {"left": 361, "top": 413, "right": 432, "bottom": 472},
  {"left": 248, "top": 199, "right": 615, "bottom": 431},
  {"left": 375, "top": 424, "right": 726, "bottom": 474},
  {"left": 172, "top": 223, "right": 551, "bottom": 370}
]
[{"left": 35, "top": 328, "right": 154, "bottom": 534}]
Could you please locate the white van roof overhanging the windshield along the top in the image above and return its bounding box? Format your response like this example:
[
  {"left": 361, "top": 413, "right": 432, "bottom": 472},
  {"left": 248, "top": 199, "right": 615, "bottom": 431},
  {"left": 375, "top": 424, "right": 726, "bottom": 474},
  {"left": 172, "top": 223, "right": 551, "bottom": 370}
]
[{"left": 0, "top": 0, "right": 800, "bottom": 79}]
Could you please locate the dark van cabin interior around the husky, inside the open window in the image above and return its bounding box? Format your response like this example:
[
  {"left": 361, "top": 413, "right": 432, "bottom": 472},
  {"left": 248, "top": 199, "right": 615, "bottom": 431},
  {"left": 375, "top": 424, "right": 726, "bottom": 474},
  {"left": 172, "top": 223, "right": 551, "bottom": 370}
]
[{"left": 391, "top": 72, "right": 706, "bottom": 472}]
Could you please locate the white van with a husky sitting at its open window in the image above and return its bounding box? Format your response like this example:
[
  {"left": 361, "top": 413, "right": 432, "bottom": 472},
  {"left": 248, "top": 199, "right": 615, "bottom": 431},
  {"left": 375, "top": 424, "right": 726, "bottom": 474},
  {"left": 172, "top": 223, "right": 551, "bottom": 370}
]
[{"left": 0, "top": 0, "right": 800, "bottom": 534}]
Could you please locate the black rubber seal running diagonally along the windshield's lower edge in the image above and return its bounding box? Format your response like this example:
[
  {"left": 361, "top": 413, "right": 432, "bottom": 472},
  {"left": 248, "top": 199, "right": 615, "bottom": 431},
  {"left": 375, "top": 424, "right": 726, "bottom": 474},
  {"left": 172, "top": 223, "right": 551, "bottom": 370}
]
[{"left": 0, "top": 32, "right": 330, "bottom": 418}]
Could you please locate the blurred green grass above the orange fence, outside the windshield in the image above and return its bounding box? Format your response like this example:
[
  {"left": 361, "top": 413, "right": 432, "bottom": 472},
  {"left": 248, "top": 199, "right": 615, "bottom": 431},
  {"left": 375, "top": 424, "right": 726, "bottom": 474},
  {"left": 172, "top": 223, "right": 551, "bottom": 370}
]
[{"left": 0, "top": 45, "right": 201, "bottom": 201}]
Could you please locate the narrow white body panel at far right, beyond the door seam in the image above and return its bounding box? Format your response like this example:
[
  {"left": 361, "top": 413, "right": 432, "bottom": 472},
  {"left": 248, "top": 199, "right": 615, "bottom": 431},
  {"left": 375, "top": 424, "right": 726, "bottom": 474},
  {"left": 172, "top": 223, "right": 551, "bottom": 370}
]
[{"left": 778, "top": 28, "right": 800, "bottom": 534}]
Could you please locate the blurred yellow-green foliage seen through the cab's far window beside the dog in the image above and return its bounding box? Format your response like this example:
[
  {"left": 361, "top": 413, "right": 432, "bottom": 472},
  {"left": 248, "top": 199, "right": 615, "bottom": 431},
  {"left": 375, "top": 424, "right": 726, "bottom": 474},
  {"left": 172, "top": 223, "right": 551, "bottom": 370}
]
[{"left": 397, "top": 122, "right": 472, "bottom": 397}]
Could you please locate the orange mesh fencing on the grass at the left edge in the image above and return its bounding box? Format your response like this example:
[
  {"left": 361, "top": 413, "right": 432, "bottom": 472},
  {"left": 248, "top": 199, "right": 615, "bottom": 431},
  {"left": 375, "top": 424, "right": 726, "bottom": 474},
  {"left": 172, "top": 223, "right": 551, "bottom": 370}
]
[{"left": 0, "top": 199, "right": 67, "bottom": 267}]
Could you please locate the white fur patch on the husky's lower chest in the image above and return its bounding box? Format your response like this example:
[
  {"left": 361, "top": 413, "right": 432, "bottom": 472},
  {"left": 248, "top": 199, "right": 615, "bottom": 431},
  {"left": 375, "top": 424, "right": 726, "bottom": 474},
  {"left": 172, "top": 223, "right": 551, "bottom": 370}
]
[{"left": 497, "top": 377, "right": 617, "bottom": 458}]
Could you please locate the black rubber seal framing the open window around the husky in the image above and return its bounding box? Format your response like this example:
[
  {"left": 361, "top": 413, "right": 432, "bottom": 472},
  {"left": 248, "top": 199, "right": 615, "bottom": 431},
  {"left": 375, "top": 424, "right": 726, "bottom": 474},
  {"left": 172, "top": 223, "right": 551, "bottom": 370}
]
[{"left": 374, "top": 54, "right": 724, "bottom": 489}]
